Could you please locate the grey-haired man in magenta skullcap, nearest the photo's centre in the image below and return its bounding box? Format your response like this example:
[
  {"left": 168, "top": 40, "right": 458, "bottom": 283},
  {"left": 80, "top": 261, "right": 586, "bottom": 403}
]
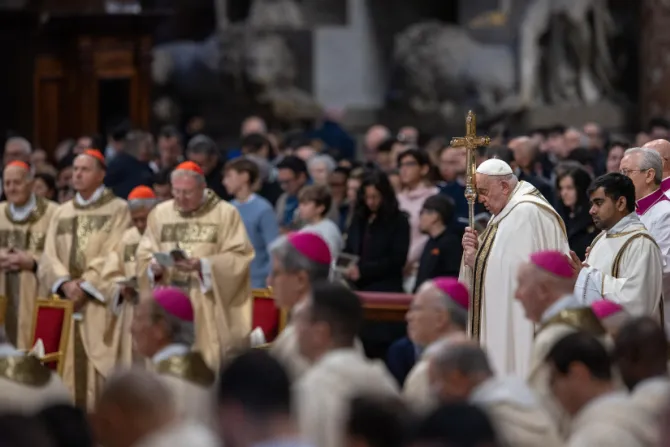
[{"left": 268, "top": 233, "right": 331, "bottom": 380}]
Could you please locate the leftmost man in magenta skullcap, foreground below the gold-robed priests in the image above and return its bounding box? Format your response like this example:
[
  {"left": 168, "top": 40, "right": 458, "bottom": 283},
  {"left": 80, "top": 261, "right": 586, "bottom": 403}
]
[{"left": 131, "top": 287, "right": 215, "bottom": 425}]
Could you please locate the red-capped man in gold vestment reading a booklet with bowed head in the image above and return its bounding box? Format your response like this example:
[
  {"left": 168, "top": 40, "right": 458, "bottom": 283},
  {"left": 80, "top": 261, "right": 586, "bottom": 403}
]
[{"left": 137, "top": 162, "right": 254, "bottom": 370}]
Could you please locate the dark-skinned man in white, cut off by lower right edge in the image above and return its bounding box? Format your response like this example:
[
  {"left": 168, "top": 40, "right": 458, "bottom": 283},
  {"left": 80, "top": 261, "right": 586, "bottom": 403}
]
[{"left": 615, "top": 317, "right": 670, "bottom": 424}]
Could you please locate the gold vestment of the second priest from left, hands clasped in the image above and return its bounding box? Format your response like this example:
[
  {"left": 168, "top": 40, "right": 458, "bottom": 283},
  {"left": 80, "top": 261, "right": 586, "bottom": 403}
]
[{"left": 38, "top": 189, "right": 130, "bottom": 408}]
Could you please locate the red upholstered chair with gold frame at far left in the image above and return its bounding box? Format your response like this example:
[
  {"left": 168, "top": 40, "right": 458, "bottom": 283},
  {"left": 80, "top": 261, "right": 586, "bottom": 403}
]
[{"left": 33, "top": 297, "right": 73, "bottom": 376}]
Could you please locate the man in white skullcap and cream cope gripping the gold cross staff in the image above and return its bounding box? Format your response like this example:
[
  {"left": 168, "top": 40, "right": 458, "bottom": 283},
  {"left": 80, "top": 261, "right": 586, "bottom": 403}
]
[{"left": 459, "top": 159, "right": 569, "bottom": 376}]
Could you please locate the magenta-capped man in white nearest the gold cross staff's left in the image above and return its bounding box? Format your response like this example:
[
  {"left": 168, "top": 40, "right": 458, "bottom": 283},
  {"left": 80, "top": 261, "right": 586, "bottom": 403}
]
[{"left": 402, "top": 278, "right": 470, "bottom": 412}]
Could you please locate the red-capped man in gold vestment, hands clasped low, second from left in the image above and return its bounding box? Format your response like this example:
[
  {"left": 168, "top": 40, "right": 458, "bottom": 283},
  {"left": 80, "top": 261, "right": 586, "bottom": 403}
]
[{"left": 38, "top": 150, "right": 130, "bottom": 407}]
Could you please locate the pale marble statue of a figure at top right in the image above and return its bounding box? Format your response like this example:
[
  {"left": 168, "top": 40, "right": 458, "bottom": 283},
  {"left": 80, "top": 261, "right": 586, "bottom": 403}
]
[{"left": 519, "top": 0, "right": 615, "bottom": 108}]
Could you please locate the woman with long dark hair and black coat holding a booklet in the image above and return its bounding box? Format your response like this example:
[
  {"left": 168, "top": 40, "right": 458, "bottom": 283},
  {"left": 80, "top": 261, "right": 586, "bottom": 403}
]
[{"left": 344, "top": 171, "right": 409, "bottom": 292}]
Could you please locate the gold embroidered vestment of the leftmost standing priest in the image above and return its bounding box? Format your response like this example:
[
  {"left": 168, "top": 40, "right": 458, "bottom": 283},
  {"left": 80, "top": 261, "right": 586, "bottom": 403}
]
[{"left": 0, "top": 197, "right": 58, "bottom": 350}]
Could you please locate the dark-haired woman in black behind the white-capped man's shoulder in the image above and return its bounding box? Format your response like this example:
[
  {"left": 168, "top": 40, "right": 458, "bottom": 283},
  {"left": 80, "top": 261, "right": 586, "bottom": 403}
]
[{"left": 556, "top": 168, "right": 598, "bottom": 259}]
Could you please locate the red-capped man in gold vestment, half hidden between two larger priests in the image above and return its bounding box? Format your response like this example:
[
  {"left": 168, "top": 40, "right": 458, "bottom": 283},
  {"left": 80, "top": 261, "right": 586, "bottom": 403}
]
[{"left": 96, "top": 186, "right": 158, "bottom": 366}]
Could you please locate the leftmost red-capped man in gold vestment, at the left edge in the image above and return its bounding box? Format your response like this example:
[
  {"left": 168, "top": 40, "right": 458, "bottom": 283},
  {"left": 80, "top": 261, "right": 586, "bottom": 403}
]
[{"left": 0, "top": 161, "right": 58, "bottom": 350}]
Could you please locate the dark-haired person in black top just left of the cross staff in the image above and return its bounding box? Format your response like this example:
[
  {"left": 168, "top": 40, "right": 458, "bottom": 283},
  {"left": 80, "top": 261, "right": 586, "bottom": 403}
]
[{"left": 414, "top": 194, "right": 463, "bottom": 293}]
